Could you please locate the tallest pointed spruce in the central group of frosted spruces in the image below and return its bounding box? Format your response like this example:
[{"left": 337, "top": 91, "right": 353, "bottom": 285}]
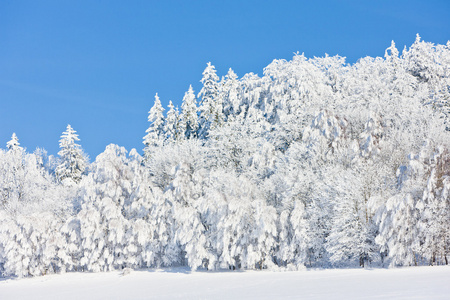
[{"left": 198, "top": 62, "right": 224, "bottom": 138}]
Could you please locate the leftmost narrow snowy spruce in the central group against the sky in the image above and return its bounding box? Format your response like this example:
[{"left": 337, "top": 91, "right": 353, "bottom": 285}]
[{"left": 143, "top": 93, "right": 164, "bottom": 159}]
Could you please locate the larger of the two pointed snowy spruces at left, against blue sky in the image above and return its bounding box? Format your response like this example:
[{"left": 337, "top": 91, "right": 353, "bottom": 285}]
[{"left": 55, "top": 125, "right": 88, "bottom": 185}]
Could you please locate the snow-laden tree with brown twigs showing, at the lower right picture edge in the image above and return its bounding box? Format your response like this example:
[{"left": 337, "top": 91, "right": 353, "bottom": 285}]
[{"left": 377, "top": 141, "right": 450, "bottom": 266}]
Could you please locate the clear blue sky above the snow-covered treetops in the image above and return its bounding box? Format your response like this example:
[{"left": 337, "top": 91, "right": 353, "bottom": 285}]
[{"left": 0, "top": 0, "right": 450, "bottom": 160}]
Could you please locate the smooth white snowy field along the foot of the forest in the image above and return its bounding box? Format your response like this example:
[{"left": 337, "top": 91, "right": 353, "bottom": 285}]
[{"left": 0, "top": 266, "right": 450, "bottom": 300}]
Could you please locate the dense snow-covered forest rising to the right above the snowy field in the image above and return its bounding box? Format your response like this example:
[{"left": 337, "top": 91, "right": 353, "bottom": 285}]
[{"left": 0, "top": 36, "right": 450, "bottom": 277}]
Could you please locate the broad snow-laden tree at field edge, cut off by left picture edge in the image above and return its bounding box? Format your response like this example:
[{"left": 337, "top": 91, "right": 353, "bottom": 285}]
[{"left": 0, "top": 149, "right": 73, "bottom": 277}]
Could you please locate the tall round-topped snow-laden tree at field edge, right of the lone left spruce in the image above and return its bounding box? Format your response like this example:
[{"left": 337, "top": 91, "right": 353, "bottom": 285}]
[{"left": 76, "top": 145, "right": 139, "bottom": 272}]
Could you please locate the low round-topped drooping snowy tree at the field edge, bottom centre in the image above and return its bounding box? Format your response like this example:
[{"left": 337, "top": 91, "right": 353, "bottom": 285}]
[{"left": 207, "top": 171, "right": 277, "bottom": 269}]
